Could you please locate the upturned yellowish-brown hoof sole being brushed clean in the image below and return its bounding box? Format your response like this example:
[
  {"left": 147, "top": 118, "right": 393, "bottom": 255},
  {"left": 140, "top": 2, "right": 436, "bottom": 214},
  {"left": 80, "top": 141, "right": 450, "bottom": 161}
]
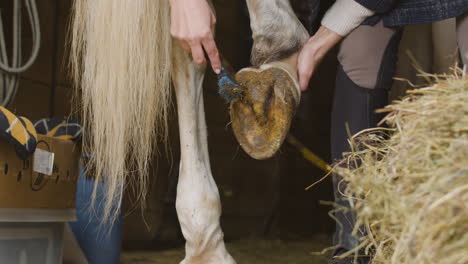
[{"left": 230, "top": 63, "right": 300, "bottom": 159}]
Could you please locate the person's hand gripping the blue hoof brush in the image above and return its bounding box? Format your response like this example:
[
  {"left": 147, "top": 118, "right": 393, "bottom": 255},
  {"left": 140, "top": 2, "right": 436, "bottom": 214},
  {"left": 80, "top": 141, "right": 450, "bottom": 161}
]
[{"left": 170, "top": 0, "right": 221, "bottom": 73}]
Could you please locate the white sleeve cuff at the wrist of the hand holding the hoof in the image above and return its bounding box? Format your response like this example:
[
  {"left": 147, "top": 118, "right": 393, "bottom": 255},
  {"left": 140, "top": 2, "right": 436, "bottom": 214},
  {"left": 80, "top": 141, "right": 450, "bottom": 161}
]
[{"left": 322, "top": 0, "right": 374, "bottom": 36}]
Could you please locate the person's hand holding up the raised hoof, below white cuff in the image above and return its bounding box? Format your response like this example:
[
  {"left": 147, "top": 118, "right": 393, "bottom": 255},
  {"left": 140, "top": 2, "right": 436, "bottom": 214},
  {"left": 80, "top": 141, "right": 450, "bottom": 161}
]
[{"left": 297, "top": 26, "right": 343, "bottom": 91}]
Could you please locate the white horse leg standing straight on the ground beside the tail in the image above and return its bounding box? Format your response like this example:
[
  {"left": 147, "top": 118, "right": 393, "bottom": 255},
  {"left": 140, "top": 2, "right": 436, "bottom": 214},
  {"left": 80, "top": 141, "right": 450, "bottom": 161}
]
[{"left": 173, "top": 43, "right": 235, "bottom": 264}]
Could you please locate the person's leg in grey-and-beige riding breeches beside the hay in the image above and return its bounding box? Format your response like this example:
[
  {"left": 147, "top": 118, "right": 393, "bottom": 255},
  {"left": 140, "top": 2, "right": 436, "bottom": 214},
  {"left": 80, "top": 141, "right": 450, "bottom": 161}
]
[{"left": 331, "top": 23, "right": 401, "bottom": 263}]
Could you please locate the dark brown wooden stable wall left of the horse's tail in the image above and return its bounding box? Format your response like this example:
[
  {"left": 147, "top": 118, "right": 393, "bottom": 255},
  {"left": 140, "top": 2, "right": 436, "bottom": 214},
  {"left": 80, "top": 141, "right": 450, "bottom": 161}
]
[{"left": 0, "top": 0, "right": 72, "bottom": 119}]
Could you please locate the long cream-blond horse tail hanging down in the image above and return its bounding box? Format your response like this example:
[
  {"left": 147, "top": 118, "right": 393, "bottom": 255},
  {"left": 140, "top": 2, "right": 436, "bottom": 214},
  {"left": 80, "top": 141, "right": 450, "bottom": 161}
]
[{"left": 69, "top": 0, "right": 172, "bottom": 221}]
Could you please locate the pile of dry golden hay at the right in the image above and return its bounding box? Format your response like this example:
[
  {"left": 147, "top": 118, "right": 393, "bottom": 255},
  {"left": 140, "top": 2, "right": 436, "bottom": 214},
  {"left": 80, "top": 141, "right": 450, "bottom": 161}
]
[{"left": 337, "top": 72, "right": 468, "bottom": 264}]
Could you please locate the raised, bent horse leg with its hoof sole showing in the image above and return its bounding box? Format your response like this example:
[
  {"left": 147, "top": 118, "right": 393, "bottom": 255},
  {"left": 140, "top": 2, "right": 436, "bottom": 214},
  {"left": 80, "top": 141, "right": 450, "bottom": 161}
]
[{"left": 230, "top": 0, "right": 309, "bottom": 159}]
